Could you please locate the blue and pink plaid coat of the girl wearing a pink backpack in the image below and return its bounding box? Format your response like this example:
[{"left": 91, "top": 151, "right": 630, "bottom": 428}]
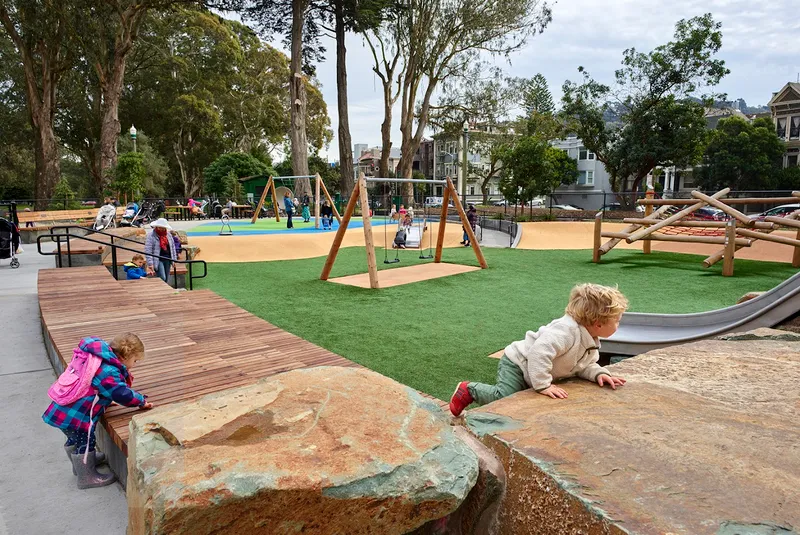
[{"left": 42, "top": 337, "right": 145, "bottom": 432}]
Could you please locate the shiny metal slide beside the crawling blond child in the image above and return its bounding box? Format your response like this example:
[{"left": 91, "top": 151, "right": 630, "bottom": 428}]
[{"left": 601, "top": 273, "right": 800, "bottom": 355}]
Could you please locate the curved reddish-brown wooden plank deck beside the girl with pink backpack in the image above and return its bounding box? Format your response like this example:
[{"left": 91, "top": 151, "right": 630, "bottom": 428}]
[{"left": 38, "top": 266, "right": 358, "bottom": 454}]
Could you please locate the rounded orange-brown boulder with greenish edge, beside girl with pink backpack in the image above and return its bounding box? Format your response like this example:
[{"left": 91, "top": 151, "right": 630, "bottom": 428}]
[{"left": 128, "top": 367, "right": 478, "bottom": 535}]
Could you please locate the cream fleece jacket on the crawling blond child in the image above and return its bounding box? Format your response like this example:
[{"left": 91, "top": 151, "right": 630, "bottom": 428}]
[{"left": 505, "top": 315, "right": 611, "bottom": 392}]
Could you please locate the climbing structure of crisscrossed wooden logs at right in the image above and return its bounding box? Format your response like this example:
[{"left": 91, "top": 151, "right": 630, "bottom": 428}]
[{"left": 592, "top": 188, "right": 800, "bottom": 277}]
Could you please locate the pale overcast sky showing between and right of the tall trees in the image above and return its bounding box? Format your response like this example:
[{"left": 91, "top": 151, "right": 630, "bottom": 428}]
[{"left": 260, "top": 0, "right": 800, "bottom": 160}]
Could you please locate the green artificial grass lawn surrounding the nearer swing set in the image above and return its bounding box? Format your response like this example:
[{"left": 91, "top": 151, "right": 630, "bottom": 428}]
[{"left": 196, "top": 248, "right": 795, "bottom": 399}]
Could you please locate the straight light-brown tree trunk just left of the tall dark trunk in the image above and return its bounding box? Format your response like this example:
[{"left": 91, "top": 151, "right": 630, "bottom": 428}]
[{"left": 289, "top": 0, "right": 311, "bottom": 198}]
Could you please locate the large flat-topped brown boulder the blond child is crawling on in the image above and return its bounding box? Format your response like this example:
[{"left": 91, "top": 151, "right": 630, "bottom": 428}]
[{"left": 467, "top": 336, "right": 800, "bottom": 535}]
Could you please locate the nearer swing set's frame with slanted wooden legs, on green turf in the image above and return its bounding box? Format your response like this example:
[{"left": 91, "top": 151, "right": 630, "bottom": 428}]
[{"left": 320, "top": 173, "right": 488, "bottom": 289}]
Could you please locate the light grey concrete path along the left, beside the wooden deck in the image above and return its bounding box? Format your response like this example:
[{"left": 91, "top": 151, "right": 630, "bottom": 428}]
[{"left": 0, "top": 244, "right": 128, "bottom": 535}]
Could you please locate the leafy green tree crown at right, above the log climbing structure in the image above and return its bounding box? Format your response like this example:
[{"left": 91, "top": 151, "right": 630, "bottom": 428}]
[{"left": 562, "top": 14, "right": 729, "bottom": 201}]
